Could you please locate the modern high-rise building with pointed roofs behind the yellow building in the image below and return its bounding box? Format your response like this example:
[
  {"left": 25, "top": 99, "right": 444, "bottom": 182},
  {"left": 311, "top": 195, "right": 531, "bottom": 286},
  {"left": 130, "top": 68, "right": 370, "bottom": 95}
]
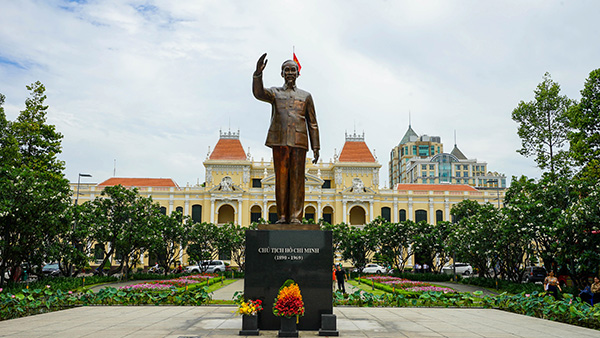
[{"left": 389, "top": 125, "right": 506, "bottom": 188}]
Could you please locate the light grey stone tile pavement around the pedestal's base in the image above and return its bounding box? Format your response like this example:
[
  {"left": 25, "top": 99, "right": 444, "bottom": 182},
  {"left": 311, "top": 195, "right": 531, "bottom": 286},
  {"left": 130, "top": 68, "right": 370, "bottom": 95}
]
[{"left": 0, "top": 306, "right": 600, "bottom": 338}]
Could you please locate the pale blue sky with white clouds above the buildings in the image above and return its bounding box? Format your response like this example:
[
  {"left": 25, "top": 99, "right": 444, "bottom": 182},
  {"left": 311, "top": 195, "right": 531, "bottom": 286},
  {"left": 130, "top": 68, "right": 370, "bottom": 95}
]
[{"left": 0, "top": 0, "right": 600, "bottom": 186}]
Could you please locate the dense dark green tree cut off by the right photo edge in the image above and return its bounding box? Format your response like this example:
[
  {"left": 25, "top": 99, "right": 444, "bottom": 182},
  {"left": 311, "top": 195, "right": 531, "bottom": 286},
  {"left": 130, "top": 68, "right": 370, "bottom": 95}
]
[{"left": 569, "top": 68, "right": 600, "bottom": 179}]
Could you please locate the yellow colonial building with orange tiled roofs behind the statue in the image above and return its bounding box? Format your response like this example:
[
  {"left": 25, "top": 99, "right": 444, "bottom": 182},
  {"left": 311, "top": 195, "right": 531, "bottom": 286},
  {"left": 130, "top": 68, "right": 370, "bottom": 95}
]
[{"left": 71, "top": 131, "right": 504, "bottom": 230}]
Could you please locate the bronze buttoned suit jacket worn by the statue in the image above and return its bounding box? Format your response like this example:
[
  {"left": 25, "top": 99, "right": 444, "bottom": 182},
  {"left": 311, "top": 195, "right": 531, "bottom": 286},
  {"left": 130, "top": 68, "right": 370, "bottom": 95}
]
[{"left": 252, "top": 75, "right": 319, "bottom": 150}]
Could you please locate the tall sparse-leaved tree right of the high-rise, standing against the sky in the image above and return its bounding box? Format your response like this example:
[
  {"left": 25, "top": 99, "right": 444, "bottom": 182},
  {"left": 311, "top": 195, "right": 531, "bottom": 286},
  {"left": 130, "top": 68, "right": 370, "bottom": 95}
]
[{"left": 512, "top": 73, "right": 573, "bottom": 174}]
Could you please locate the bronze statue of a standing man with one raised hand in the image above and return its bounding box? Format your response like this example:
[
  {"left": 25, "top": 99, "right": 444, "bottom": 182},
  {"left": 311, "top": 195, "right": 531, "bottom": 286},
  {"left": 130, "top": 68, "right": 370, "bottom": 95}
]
[{"left": 252, "top": 53, "right": 319, "bottom": 224}]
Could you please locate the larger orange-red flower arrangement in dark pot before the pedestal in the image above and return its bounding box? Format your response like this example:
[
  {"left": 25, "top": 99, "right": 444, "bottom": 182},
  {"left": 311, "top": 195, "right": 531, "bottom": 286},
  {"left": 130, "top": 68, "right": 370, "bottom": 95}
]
[{"left": 273, "top": 279, "right": 304, "bottom": 337}]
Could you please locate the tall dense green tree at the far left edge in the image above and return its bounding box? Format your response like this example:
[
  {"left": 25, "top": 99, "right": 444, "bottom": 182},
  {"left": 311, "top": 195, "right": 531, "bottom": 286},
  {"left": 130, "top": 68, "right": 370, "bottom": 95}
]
[{"left": 0, "top": 81, "right": 71, "bottom": 282}]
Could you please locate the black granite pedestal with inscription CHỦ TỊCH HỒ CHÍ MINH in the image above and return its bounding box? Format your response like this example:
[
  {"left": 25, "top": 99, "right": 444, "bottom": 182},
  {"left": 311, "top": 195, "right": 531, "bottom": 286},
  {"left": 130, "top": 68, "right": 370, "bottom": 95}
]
[{"left": 244, "top": 226, "right": 333, "bottom": 331}]
